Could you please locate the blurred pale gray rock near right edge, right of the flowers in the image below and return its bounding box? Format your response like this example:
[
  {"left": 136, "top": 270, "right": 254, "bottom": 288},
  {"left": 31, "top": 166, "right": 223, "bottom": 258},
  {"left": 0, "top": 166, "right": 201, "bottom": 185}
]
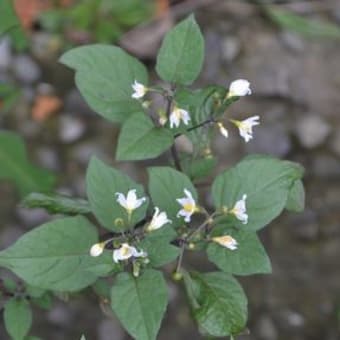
[{"left": 295, "top": 114, "right": 331, "bottom": 149}]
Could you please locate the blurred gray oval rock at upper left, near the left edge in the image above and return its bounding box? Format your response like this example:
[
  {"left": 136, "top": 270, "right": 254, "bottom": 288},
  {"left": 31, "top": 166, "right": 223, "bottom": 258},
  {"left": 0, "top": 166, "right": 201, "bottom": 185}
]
[{"left": 13, "top": 54, "right": 41, "bottom": 84}]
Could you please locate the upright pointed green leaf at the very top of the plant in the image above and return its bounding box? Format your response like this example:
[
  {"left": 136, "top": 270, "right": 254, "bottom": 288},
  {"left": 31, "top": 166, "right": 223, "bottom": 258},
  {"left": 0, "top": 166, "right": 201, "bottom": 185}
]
[{"left": 156, "top": 15, "right": 204, "bottom": 85}]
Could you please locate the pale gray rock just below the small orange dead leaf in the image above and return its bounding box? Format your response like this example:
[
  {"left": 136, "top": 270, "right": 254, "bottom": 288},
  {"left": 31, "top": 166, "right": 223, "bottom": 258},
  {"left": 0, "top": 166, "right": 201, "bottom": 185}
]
[{"left": 59, "top": 114, "right": 86, "bottom": 143}]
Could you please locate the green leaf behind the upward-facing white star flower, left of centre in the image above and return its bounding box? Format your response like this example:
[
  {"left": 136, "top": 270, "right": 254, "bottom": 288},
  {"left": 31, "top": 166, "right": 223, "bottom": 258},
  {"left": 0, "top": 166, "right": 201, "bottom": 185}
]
[{"left": 86, "top": 157, "right": 148, "bottom": 232}]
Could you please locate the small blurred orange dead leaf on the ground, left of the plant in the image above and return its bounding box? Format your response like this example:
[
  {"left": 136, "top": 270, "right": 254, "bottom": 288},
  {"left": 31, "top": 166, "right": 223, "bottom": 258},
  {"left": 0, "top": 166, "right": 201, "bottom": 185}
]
[{"left": 32, "top": 95, "right": 62, "bottom": 122}]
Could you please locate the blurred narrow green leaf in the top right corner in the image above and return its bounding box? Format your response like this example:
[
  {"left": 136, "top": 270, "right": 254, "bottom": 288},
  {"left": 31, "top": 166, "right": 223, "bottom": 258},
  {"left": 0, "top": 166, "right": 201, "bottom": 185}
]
[{"left": 265, "top": 6, "right": 340, "bottom": 39}]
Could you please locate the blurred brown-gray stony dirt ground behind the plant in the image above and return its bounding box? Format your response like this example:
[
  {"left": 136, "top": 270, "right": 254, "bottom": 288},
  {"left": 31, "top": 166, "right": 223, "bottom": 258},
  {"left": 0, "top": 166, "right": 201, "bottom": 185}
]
[{"left": 0, "top": 0, "right": 340, "bottom": 340}]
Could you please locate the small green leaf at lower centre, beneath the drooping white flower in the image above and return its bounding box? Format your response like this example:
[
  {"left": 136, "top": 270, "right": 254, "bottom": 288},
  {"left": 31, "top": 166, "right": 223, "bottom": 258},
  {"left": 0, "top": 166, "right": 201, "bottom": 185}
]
[{"left": 139, "top": 225, "right": 179, "bottom": 267}]
